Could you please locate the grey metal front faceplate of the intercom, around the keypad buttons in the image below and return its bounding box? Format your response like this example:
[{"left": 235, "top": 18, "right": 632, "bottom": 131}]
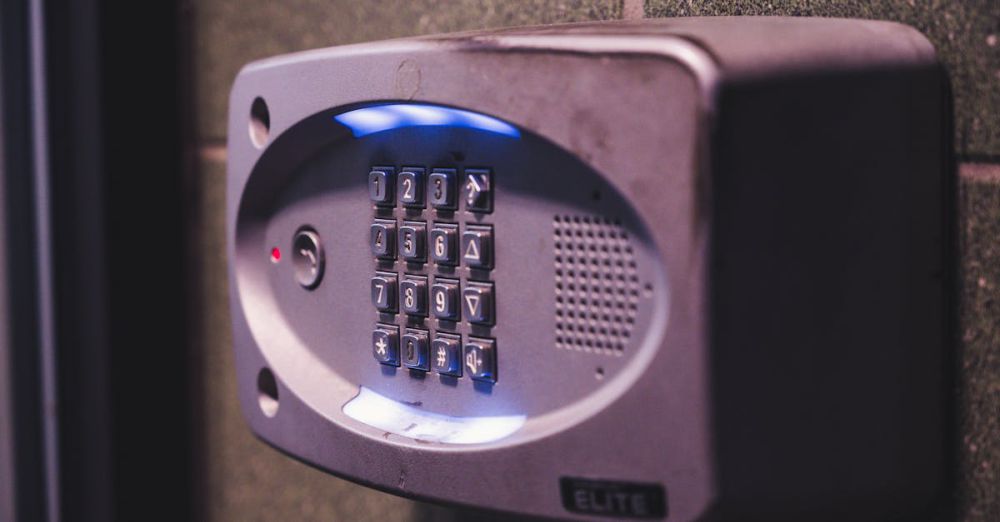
[{"left": 227, "top": 29, "right": 711, "bottom": 518}]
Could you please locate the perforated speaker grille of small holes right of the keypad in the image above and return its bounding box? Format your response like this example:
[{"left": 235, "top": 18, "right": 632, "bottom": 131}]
[{"left": 552, "top": 215, "right": 639, "bottom": 355}]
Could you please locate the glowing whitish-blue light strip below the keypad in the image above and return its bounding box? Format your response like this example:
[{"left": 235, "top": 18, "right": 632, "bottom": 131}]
[{"left": 344, "top": 386, "right": 526, "bottom": 444}]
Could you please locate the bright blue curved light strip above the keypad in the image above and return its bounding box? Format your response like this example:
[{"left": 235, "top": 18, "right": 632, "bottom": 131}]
[{"left": 333, "top": 103, "right": 521, "bottom": 138}]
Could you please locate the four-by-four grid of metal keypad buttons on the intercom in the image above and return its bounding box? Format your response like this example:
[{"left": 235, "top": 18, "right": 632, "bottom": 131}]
[{"left": 368, "top": 166, "right": 497, "bottom": 383}]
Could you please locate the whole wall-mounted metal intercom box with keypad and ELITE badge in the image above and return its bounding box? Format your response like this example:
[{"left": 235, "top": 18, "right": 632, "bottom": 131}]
[{"left": 226, "top": 18, "right": 951, "bottom": 521}]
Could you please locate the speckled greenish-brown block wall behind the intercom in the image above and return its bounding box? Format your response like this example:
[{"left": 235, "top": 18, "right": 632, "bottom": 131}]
[{"left": 188, "top": 0, "right": 1000, "bottom": 522}]
